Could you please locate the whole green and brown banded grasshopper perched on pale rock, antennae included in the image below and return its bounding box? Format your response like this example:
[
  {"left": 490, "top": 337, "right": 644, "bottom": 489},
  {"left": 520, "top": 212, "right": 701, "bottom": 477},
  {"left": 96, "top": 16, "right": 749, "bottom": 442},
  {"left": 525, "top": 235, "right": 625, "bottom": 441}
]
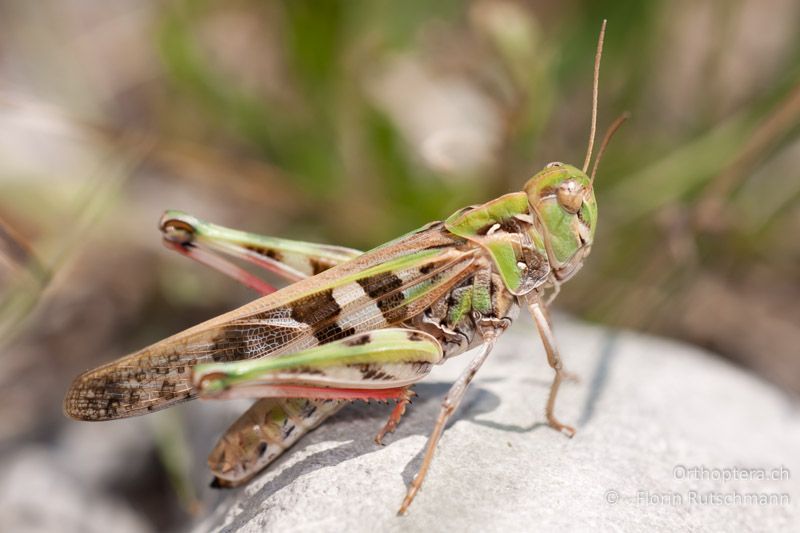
[{"left": 64, "top": 21, "right": 624, "bottom": 514}]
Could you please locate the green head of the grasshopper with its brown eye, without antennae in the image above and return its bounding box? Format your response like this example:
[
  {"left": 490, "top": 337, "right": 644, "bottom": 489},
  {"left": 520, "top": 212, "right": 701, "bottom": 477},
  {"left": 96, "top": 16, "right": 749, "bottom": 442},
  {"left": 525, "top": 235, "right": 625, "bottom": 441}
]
[{"left": 525, "top": 163, "right": 597, "bottom": 280}]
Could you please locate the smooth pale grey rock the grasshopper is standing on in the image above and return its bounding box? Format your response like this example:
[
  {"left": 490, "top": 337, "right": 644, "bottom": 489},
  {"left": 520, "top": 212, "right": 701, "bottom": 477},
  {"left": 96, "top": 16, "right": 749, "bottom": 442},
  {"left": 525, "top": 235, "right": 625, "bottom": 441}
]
[{"left": 194, "top": 319, "right": 800, "bottom": 532}]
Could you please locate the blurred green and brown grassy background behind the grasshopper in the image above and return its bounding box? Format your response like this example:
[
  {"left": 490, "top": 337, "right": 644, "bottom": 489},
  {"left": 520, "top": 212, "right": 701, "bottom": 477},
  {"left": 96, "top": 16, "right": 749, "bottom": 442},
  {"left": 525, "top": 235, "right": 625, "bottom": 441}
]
[{"left": 0, "top": 0, "right": 800, "bottom": 531}]
